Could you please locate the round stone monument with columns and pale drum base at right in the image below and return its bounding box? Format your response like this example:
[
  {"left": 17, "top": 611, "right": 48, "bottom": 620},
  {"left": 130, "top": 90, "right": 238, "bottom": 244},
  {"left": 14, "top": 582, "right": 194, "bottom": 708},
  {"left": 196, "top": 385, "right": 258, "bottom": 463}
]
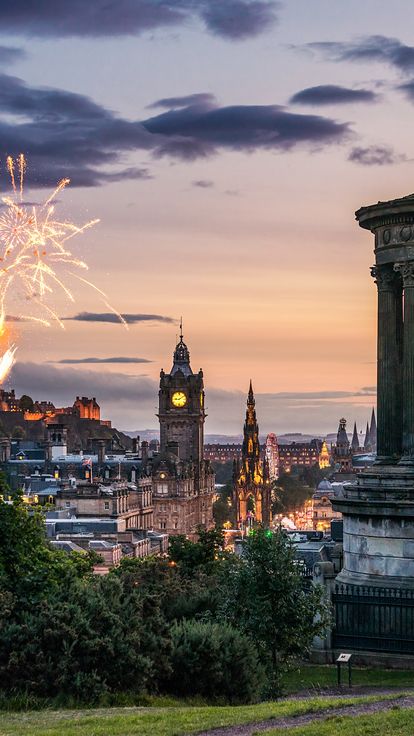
[{"left": 334, "top": 194, "right": 414, "bottom": 590}]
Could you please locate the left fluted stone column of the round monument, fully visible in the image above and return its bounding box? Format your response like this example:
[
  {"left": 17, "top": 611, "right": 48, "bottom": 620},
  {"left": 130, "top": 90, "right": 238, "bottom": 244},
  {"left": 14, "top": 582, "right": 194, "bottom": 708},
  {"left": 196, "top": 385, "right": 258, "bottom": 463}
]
[{"left": 371, "top": 264, "right": 403, "bottom": 462}]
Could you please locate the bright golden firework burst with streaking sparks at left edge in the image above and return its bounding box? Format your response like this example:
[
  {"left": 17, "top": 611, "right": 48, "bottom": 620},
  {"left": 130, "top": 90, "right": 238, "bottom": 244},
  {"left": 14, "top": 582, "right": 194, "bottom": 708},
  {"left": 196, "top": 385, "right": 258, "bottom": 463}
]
[{"left": 0, "top": 153, "right": 128, "bottom": 382}]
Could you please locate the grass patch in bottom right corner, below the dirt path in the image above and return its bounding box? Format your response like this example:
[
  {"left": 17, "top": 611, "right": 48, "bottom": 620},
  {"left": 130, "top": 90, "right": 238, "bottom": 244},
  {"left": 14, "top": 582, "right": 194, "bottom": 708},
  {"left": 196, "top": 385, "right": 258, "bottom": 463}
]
[{"left": 266, "top": 707, "right": 414, "bottom": 736}]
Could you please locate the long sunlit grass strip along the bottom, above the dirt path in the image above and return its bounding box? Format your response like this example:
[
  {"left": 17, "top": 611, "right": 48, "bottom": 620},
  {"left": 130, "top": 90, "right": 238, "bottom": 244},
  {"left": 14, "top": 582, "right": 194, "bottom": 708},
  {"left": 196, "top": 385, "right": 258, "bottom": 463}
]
[{"left": 0, "top": 696, "right": 404, "bottom": 736}]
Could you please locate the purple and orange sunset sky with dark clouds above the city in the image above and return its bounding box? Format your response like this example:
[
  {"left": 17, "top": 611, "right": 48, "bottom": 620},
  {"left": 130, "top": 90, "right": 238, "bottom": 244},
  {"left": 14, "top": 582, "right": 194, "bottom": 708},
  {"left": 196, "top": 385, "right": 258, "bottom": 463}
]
[{"left": 0, "top": 0, "right": 414, "bottom": 434}]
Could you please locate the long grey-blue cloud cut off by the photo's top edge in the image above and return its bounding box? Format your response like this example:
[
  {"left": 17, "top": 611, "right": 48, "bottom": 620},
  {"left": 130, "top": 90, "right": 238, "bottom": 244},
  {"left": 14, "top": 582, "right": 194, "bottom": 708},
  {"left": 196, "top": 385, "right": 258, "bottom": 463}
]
[{"left": 0, "top": 0, "right": 279, "bottom": 40}]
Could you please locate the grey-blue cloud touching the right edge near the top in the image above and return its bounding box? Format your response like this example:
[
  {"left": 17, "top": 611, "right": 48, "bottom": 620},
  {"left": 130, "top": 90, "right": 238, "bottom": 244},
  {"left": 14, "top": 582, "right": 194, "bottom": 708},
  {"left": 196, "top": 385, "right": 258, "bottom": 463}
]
[{"left": 306, "top": 36, "right": 414, "bottom": 72}]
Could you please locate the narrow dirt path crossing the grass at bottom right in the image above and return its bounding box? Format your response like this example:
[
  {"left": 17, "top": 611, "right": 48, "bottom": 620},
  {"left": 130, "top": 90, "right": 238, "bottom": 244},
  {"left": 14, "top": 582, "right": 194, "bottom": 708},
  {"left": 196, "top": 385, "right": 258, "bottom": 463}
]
[{"left": 197, "top": 696, "right": 414, "bottom": 736}]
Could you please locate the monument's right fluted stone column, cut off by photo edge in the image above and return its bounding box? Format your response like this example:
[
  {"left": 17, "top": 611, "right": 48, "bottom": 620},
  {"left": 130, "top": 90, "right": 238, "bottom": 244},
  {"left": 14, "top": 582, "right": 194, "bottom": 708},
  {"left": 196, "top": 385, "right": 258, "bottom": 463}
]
[{"left": 394, "top": 261, "right": 414, "bottom": 464}]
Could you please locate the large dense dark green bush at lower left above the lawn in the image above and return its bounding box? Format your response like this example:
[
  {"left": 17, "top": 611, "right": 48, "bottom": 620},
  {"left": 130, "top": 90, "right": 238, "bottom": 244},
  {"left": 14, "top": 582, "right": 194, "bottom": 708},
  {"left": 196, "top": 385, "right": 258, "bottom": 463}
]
[{"left": 0, "top": 575, "right": 171, "bottom": 702}]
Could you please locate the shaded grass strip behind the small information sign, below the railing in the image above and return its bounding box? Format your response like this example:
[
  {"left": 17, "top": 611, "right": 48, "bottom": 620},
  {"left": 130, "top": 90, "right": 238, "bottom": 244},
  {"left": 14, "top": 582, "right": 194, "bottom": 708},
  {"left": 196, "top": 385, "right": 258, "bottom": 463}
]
[{"left": 283, "top": 665, "right": 414, "bottom": 695}]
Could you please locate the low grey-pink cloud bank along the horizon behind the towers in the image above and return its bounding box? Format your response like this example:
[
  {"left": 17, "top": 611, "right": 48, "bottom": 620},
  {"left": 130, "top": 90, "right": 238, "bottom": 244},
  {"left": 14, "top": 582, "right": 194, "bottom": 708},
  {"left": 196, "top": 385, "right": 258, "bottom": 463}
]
[{"left": 9, "top": 356, "right": 375, "bottom": 435}]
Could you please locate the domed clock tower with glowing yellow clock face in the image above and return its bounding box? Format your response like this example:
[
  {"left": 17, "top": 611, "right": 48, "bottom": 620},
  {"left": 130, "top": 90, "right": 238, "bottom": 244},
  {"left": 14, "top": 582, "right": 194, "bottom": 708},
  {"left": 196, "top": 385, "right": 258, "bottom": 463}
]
[{"left": 158, "top": 326, "right": 206, "bottom": 465}]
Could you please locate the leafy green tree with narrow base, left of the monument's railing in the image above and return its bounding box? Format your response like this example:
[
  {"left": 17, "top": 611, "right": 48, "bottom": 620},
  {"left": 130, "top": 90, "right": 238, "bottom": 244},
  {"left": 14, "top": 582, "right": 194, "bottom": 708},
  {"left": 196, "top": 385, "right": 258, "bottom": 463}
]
[{"left": 219, "top": 529, "right": 329, "bottom": 694}]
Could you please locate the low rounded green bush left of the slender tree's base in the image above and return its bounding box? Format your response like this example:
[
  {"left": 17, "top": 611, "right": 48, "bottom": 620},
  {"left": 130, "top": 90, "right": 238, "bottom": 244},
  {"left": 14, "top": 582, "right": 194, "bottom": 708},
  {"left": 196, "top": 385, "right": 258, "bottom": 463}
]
[{"left": 166, "top": 621, "right": 265, "bottom": 703}]
